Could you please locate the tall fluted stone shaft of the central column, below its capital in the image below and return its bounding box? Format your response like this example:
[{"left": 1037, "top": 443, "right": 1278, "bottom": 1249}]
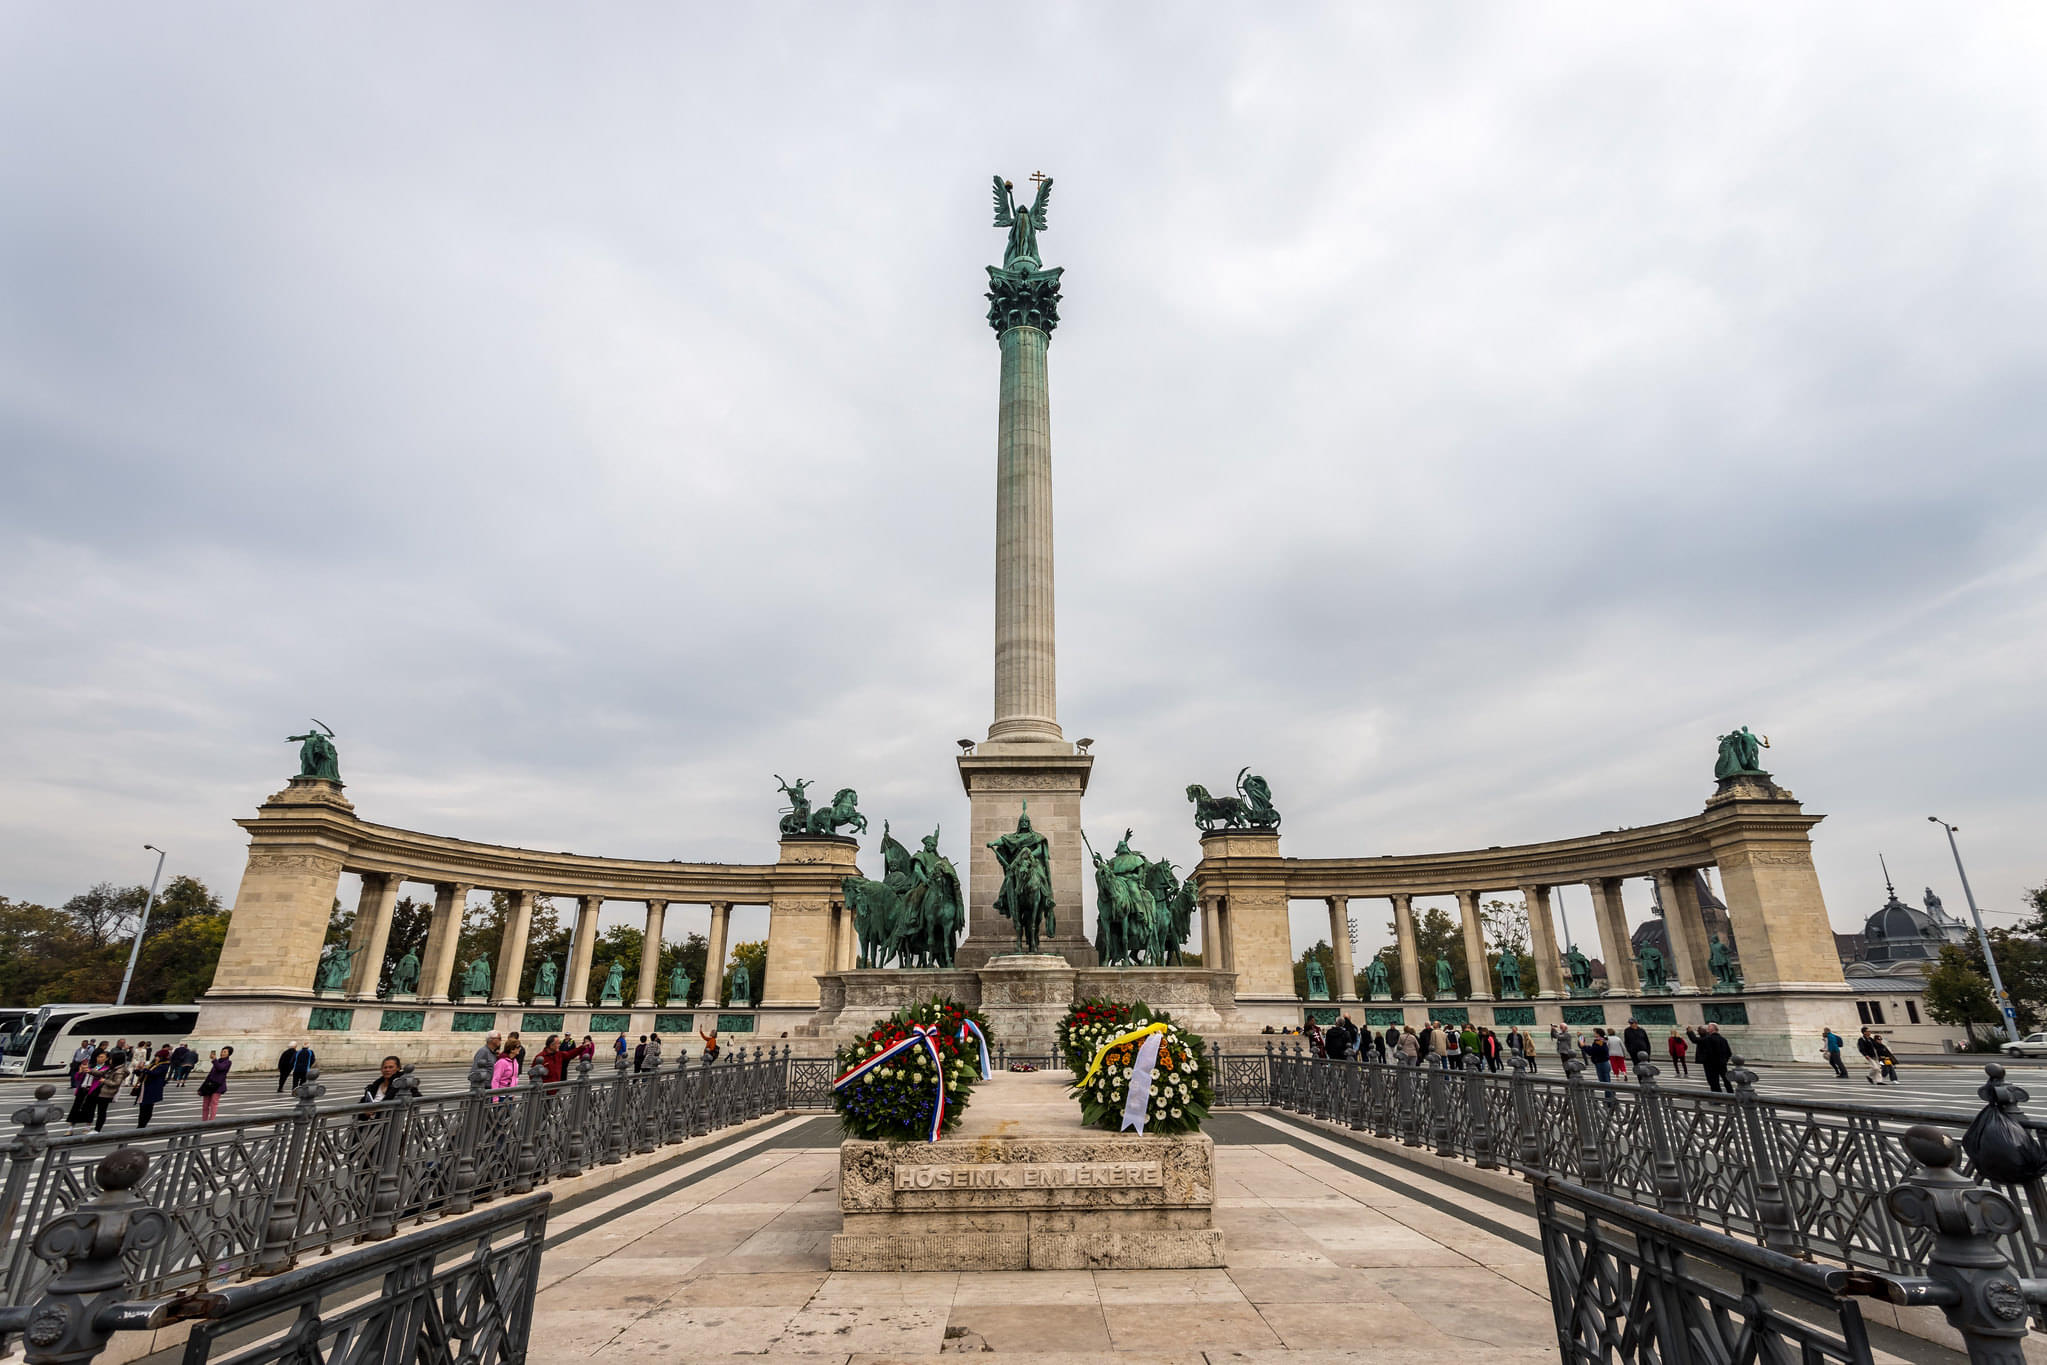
[{"left": 989, "top": 327, "right": 1060, "bottom": 741}]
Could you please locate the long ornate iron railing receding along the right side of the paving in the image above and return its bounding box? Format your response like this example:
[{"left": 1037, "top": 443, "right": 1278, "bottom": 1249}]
[{"left": 1252, "top": 1046, "right": 2047, "bottom": 1275}]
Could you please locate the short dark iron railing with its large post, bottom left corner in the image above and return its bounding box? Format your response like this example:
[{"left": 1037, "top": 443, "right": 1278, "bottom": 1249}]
[{"left": 0, "top": 1148, "right": 555, "bottom": 1365}]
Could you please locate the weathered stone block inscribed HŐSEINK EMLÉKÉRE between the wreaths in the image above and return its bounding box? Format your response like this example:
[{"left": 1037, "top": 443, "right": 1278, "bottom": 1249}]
[{"left": 831, "top": 1072, "right": 1222, "bottom": 1271}]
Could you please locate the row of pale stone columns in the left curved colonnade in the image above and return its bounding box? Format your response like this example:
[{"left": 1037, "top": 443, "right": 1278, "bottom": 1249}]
[{"left": 344, "top": 868, "right": 759, "bottom": 1009}]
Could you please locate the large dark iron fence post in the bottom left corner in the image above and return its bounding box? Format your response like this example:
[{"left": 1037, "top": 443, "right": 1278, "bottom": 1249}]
[{"left": 0, "top": 1146, "right": 170, "bottom": 1365}]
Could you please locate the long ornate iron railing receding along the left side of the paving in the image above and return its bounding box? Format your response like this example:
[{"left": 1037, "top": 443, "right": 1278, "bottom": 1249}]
[{"left": 0, "top": 1048, "right": 790, "bottom": 1304}]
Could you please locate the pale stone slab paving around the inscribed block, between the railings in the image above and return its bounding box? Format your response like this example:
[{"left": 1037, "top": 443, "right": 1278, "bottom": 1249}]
[{"left": 491, "top": 1113, "right": 1957, "bottom": 1365}]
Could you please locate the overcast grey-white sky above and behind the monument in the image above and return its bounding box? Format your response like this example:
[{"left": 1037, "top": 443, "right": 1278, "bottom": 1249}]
[{"left": 0, "top": 13, "right": 2047, "bottom": 970}]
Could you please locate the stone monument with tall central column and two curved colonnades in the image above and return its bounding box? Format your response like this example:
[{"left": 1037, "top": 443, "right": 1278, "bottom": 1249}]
[{"left": 194, "top": 176, "right": 1855, "bottom": 1064}]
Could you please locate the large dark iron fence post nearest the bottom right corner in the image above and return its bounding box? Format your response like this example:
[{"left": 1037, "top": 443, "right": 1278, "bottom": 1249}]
[{"left": 1883, "top": 1121, "right": 2047, "bottom": 1365}]
